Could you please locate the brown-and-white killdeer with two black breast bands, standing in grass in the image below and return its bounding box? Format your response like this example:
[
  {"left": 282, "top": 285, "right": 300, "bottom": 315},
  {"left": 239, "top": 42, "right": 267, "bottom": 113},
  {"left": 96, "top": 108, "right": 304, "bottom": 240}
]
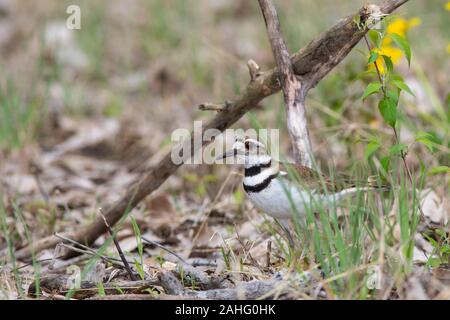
[{"left": 217, "top": 138, "right": 384, "bottom": 226}]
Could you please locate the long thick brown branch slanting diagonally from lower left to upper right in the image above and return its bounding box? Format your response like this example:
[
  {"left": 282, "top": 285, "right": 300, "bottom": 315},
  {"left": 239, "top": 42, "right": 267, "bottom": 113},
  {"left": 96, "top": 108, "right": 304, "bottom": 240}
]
[{"left": 11, "top": 0, "right": 408, "bottom": 259}]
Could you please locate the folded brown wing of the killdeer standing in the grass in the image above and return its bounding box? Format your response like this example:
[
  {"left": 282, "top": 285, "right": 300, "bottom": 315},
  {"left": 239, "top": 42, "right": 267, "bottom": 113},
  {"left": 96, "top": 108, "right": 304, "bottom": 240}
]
[{"left": 279, "top": 163, "right": 355, "bottom": 193}]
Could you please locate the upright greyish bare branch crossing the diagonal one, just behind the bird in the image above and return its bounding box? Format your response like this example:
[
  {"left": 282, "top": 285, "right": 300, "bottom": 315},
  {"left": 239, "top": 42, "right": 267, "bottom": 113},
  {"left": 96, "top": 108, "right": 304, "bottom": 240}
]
[{"left": 258, "top": 0, "right": 313, "bottom": 168}]
